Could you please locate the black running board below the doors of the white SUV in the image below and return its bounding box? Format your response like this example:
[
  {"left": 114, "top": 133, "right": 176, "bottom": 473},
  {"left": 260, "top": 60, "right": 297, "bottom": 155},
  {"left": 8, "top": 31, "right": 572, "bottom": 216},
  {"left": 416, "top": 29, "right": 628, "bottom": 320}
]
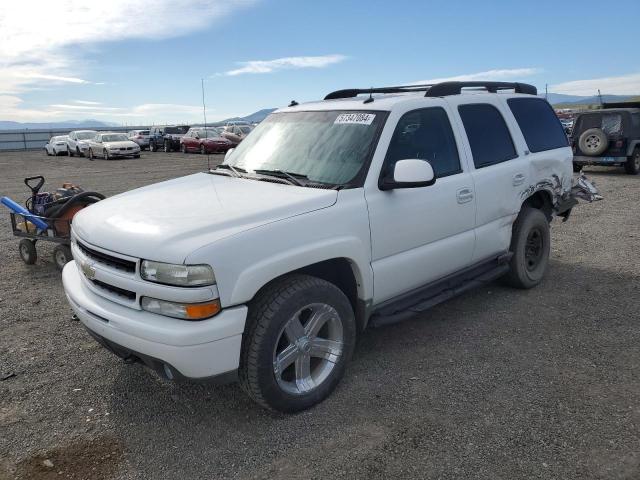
[{"left": 369, "top": 253, "right": 513, "bottom": 328}]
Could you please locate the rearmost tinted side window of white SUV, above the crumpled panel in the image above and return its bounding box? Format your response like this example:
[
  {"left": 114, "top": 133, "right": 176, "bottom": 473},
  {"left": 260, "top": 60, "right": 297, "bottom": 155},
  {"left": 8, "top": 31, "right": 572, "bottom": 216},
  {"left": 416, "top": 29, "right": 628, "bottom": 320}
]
[{"left": 507, "top": 98, "right": 568, "bottom": 152}]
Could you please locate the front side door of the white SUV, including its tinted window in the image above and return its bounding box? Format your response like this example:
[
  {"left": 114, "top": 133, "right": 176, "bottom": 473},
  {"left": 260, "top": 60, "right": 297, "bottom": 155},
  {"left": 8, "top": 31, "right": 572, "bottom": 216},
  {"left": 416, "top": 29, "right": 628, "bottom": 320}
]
[{"left": 366, "top": 107, "right": 476, "bottom": 304}]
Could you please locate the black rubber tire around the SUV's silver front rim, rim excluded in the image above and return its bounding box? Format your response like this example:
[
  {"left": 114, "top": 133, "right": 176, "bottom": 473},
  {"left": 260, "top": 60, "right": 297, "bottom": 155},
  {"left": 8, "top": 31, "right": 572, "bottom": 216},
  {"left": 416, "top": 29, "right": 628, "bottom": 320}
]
[{"left": 239, "top": 274, "right": 356, "bottom": 413}]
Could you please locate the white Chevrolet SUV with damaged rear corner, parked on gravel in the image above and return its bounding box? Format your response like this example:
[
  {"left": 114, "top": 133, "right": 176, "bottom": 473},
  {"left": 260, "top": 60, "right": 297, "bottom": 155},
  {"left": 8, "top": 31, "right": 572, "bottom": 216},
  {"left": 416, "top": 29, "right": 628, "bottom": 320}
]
[{"left": 63, "top": 82, "right": 594, "bottom": 412}]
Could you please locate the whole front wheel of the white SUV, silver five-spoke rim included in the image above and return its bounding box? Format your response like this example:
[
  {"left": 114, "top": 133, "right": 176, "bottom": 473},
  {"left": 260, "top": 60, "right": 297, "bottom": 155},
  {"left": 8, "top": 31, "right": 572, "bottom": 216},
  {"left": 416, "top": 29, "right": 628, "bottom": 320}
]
[{"left": 239, "top": 274, "right": 356, "bottom": 413}]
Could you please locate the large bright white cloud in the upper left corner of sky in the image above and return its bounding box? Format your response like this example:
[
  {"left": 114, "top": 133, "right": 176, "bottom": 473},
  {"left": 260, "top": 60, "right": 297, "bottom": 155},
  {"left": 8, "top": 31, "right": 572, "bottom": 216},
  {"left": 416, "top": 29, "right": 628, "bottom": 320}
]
[{"left": 0, "top": 0, "right": 257, "bottom": 94}]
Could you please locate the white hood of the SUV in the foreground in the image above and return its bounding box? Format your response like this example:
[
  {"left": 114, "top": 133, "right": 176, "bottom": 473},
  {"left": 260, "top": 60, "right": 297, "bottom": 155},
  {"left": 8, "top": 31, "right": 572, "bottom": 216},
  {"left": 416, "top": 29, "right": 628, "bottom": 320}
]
[{"left": 73, "top": 173, "right": 338, "bottom": 263}]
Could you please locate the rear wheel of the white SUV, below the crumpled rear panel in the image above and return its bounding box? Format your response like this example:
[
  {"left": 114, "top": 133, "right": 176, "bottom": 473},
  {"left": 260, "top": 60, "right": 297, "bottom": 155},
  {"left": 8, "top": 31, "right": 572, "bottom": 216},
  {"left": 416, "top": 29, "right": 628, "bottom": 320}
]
[{"left": 505, "top": 207, "right": 551, "bottom": 289}]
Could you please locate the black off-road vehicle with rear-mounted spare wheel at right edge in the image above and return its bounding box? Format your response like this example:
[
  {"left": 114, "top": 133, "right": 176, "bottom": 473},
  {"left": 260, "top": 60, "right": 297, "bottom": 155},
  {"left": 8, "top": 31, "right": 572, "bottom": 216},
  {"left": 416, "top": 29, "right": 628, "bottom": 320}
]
[{"left": 571, "top": 102, "right": 640, "bottom": 175}]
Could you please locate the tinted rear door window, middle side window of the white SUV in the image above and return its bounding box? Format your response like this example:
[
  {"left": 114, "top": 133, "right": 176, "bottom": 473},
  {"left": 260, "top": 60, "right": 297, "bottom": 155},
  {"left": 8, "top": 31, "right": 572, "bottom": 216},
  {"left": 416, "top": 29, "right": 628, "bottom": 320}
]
[{"left": 458, "top": 103, "right": 518, "bottom": 168}]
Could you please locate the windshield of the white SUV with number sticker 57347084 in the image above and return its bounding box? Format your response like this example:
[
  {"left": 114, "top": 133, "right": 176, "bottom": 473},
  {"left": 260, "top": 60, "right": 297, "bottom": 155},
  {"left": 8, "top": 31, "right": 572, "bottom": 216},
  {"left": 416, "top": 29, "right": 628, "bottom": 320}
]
[{"left": 224, "top": 111, "right": 385, "bottom": 185}]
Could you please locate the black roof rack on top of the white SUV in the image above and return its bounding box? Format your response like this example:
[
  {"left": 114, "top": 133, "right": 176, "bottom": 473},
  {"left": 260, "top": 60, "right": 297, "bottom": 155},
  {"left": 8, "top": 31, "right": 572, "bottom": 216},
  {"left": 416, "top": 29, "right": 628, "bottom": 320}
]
[{"left": 324, "top": 82, "right": 538, "bottom": 100}]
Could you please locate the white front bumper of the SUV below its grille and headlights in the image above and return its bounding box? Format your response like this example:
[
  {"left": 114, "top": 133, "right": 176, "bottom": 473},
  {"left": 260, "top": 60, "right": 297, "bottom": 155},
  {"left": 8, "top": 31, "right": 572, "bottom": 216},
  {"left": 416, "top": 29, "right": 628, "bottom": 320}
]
[{"left": 62, "top": 261, "right": 247, "bottom": 380}]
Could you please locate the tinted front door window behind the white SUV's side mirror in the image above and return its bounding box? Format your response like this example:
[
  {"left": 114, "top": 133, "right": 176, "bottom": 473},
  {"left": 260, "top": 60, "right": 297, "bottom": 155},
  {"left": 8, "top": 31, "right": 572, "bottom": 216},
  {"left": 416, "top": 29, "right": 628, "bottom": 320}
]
[{"left": 384, "top": 107, "right": 462, "bottom": 178}]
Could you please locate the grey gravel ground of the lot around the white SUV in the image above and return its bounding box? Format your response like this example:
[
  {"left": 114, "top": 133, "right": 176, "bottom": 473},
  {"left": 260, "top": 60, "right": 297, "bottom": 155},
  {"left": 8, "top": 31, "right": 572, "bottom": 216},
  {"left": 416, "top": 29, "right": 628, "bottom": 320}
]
[{"left": 0, "top": 152, "right": 640, "bottom": 480}]
